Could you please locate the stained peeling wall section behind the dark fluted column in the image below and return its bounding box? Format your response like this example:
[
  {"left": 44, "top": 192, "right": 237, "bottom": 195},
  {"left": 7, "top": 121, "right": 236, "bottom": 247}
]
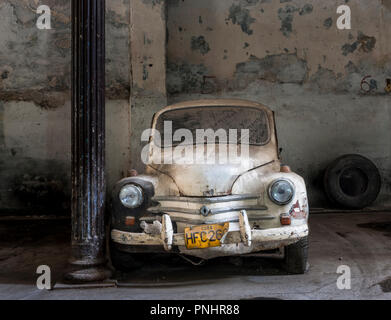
[{"left": 0, "top": 0, "right": 130, "bottom": 215}]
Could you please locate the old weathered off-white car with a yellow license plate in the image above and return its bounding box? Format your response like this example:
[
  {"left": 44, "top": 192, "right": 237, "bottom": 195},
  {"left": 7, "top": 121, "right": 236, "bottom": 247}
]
[{"left": 110, "top": 99, "right": 309, "bottom": 273}]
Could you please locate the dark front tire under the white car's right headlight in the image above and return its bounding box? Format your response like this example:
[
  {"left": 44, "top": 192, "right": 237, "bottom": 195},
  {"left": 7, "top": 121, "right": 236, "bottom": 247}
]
[{"left": 284, "top": 237, "right": 308, "bottom": 274}]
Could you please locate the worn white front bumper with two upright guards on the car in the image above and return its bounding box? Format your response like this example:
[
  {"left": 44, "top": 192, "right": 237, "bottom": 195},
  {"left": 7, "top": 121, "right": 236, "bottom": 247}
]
[{"left": 111, "top": 210, "right": 308, "bottom": 251}]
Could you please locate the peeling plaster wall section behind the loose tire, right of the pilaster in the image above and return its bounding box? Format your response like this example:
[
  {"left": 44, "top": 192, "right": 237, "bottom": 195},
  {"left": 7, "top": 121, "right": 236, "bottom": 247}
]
[{"left": 167, "top": 0, "right": 391, "bottom": 207}]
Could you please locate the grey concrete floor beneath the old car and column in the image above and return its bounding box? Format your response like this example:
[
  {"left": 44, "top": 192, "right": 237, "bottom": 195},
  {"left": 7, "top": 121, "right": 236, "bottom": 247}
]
[{"left": 0, "top": 212, "right": 391, "bottom": 300}]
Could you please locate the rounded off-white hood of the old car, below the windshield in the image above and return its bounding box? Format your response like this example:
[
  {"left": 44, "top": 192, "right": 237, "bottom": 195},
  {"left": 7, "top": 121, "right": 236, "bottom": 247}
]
[{"left": 149, "top": 146, "right": 279, "bottom": 197}]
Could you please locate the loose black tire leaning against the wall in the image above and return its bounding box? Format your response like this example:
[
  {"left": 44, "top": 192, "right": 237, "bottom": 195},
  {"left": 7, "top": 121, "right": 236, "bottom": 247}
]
[{"left": 324, "top": 154, "right": 381, "bottom": 209}]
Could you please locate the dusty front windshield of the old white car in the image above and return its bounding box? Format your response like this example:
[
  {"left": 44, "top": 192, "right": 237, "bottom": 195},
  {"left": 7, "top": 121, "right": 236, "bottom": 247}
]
[{"left": 154, "top": 106, "right": 270, "bottom": 147}]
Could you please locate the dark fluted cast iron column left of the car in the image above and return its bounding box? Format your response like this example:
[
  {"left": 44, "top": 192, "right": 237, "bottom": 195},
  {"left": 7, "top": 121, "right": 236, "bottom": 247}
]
[{"left": 66, "top": 0, "right": 108, "bottom": 281}]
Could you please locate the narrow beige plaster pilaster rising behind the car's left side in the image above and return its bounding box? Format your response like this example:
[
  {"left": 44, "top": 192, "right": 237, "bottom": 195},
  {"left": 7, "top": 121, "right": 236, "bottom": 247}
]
[{"left": 130, "top": 0, "right": 167, "bottom": 172}]
